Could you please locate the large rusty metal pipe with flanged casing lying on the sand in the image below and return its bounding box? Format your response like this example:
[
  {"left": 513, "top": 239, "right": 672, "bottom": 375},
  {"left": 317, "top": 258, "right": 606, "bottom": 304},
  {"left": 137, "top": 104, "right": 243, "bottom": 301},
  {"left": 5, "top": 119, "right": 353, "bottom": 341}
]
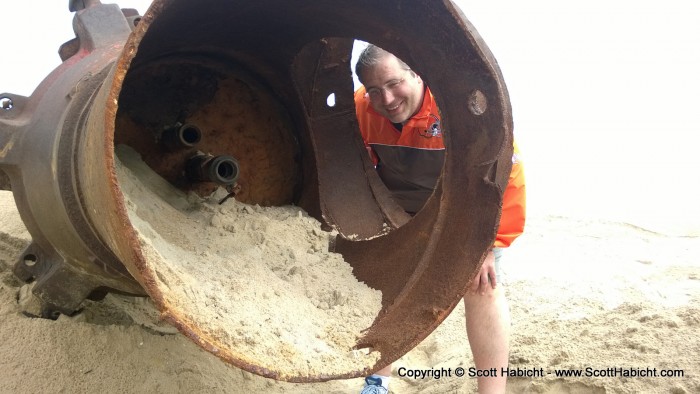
[{"left": 0, "top": 0, "right": 512, "bottom": 382}]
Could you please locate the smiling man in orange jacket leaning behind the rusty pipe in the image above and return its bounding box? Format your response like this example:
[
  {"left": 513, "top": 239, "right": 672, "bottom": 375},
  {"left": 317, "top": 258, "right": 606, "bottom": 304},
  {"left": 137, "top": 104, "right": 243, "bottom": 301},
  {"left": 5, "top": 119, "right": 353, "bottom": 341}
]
[{"left": 355, "top": 44, "right": 525, "bottom": 393}]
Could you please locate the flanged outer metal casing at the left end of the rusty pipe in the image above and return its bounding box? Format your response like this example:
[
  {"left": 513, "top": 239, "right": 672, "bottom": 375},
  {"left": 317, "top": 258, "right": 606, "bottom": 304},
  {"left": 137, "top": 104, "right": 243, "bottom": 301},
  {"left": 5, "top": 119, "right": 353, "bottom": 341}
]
[{"left": 0, "top": 5, "right": 145, "bottom": 316}]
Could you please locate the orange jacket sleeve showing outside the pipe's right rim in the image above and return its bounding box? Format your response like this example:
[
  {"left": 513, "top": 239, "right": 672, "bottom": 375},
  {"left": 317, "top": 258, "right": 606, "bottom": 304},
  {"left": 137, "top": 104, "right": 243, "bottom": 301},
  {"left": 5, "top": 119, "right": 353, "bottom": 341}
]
[{"left": 493, "top": 143, "right": 525, "bottom": 248}]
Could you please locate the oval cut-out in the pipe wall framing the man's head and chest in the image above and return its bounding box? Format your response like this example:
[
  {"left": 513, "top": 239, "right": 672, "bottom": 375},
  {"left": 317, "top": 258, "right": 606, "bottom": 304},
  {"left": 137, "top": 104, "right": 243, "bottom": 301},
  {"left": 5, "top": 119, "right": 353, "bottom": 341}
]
[{"left": 351, "top": 41, "right": 442, "bottom": 215}]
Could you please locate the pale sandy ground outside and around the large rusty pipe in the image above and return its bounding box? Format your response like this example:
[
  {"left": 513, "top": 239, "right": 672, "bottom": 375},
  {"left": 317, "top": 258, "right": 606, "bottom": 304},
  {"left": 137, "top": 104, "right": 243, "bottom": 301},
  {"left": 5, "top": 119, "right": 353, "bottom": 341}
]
[{"left": 0, "top": 192, "right": 700, "bottom": 393}]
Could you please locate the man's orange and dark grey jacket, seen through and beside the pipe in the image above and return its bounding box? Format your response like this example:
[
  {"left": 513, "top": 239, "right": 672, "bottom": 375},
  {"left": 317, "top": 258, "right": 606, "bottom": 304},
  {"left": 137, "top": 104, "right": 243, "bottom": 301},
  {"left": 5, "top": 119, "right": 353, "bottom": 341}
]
[{"left": 355, "top": 87, "right": 525, "bottom": 247}]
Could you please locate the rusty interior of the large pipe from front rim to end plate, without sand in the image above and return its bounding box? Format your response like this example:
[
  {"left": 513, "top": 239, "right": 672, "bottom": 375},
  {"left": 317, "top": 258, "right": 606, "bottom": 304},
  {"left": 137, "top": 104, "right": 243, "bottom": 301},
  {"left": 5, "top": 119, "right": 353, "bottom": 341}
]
[{"left": 88, "top": 0, "right": 512, "bottom": 382}]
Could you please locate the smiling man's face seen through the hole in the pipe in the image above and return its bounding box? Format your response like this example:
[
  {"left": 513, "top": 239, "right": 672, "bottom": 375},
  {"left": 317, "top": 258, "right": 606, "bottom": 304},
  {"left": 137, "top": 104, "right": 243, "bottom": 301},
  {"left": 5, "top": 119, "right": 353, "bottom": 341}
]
[{"left": 363, "top": 55, "right": 424, "bottom": 123}]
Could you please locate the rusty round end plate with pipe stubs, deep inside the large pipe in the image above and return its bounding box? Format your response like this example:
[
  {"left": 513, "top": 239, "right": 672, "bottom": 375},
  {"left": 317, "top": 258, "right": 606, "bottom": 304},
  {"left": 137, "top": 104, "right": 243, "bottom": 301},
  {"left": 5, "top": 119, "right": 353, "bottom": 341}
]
[{"left": 114, "top": 59, "right": 301, "bottom": 206}]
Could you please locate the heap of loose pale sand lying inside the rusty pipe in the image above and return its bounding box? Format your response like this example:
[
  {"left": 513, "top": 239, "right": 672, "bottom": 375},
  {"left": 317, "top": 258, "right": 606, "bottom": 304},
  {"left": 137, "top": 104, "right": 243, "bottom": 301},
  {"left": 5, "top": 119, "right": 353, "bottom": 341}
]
[{"left": 115, "top": 145, "right": 381, "bottom": 376}]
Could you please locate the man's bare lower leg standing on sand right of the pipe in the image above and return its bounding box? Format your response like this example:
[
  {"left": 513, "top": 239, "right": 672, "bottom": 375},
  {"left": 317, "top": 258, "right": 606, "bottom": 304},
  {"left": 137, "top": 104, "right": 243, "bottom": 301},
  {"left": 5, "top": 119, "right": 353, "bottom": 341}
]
[{"left": 464, "top": 286, "right": 510, "bottom": 394}]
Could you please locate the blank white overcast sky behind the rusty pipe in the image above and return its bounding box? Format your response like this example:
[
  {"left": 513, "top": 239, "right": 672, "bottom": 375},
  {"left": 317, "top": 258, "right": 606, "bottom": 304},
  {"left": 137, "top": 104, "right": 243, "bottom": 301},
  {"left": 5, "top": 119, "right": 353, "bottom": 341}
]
[{"left": 0, "top": 0, "right": 700, "bottom": 232}]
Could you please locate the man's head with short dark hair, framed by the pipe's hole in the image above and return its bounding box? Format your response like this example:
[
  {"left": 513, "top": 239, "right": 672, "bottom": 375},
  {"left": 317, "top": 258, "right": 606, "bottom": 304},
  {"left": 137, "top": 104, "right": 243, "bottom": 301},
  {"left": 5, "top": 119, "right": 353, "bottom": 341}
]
[{"left": 355, "top": 44, "right": 425, "bottom": 123}]
